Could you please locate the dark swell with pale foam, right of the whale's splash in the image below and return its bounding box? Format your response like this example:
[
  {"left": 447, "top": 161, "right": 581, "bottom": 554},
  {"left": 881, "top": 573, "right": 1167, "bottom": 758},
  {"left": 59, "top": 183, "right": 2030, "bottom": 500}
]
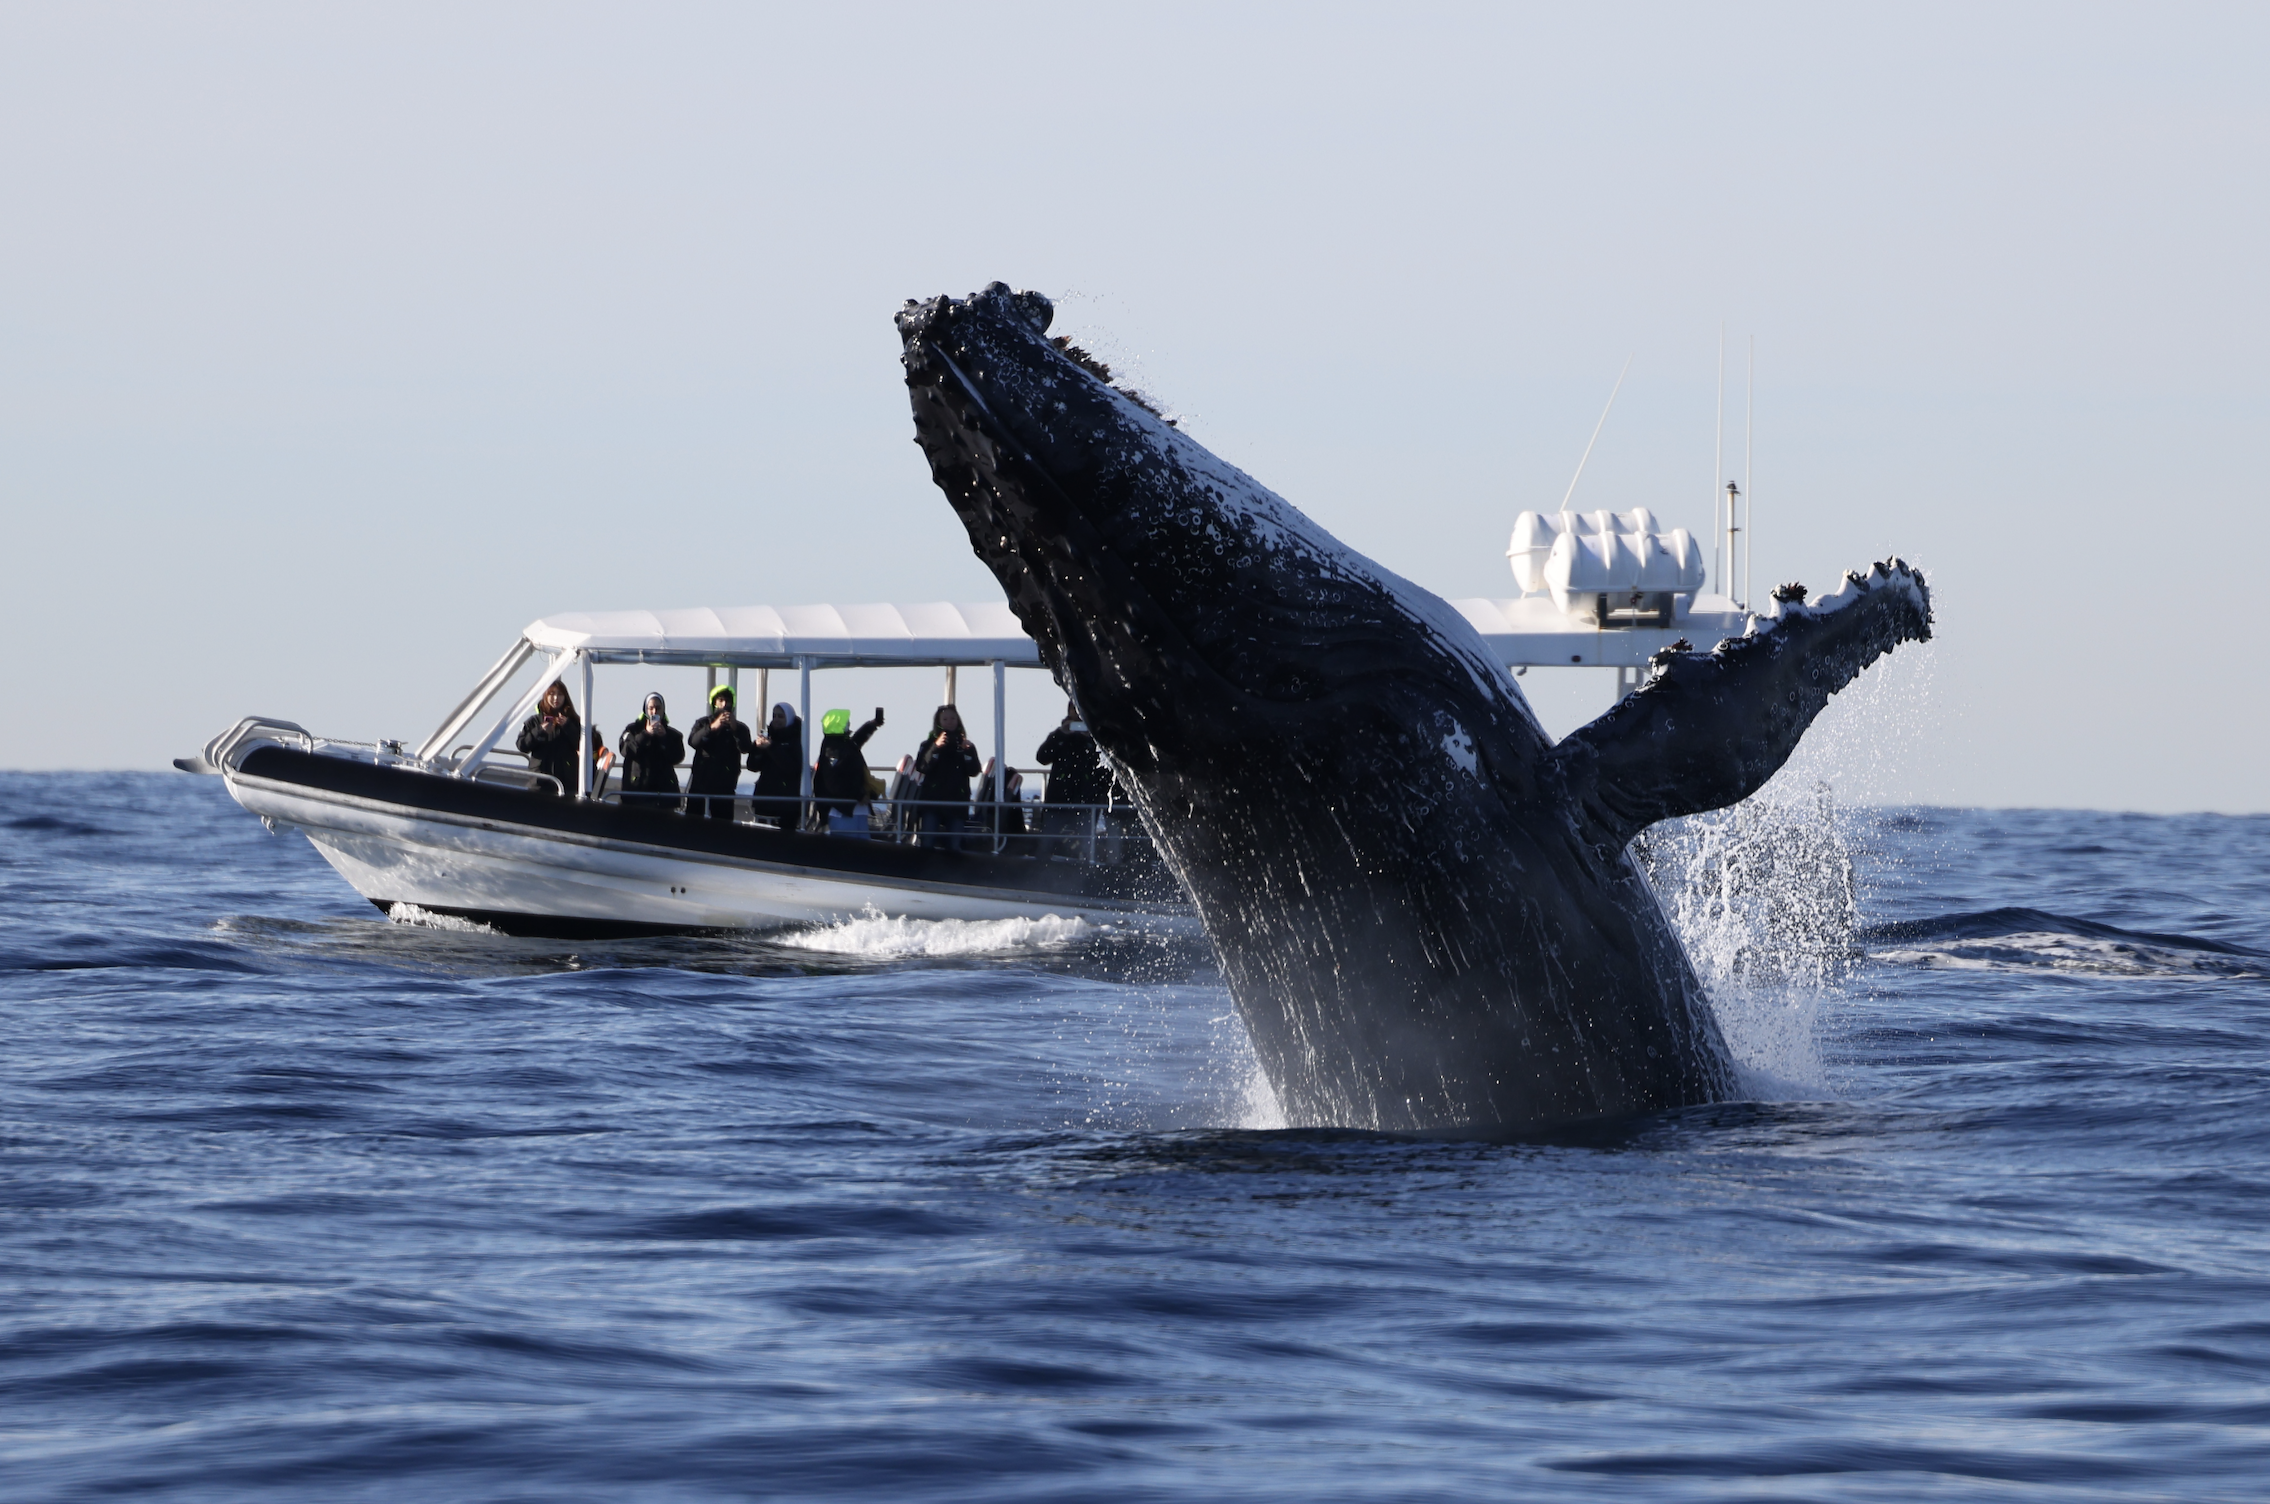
[{"left": 1859, "top": 907, "right": 2270, "bottom": 978}]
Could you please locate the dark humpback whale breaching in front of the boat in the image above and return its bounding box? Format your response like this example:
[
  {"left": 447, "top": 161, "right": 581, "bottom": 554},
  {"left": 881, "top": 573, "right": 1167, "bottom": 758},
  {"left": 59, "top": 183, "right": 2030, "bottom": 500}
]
[{"left": 897, "top": 281, "right": 1932, "bottom": 1132}]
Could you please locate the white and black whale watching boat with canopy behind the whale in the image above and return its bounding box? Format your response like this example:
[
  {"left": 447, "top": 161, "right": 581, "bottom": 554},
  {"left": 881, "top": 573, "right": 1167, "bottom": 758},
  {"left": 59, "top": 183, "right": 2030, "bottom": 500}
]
[{"left": 175, "top": 510, "right": 1750, "bottom": 937}]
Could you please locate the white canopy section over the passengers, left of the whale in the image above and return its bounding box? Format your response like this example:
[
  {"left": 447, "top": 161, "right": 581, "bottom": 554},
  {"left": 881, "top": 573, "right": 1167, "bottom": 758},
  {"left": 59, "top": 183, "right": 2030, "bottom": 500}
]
[{"left": 522, "top": 601, "right": 1040, "bottom": 667}]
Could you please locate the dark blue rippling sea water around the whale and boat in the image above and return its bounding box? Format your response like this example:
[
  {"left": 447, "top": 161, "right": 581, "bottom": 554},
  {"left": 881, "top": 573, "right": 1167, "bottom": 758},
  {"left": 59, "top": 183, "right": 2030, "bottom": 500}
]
[{"left": 0, "top": 774, "right": 2270, "bottom": 1502}]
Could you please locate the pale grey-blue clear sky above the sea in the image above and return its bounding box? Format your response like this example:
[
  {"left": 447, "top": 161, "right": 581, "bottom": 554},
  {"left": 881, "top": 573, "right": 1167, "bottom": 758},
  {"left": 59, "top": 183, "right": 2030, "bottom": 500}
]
[{"left": 0, "top": 2, "right": 2270, "bottom": 812}]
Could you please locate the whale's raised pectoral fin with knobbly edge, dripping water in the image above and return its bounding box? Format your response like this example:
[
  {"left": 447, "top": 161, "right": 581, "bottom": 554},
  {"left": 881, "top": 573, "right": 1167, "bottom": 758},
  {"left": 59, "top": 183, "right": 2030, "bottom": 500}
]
[{"left": 1553, "top": 558, "right": 1932, "bottom": 851}]
